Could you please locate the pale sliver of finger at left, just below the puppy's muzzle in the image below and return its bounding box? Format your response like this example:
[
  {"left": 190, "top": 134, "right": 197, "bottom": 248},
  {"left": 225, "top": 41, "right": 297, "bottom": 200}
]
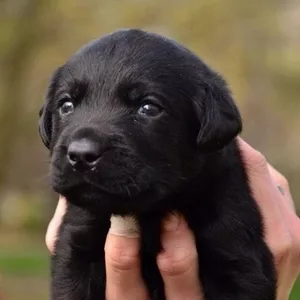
[{"left": 45, "top": 196, "right": 67, "bottom": 253}]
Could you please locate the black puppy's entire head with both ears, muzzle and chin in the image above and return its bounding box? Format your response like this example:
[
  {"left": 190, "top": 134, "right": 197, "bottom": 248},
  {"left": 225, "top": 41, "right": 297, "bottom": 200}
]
[{"left": 40, "top": 30, "right": 241, "bottom": 213}]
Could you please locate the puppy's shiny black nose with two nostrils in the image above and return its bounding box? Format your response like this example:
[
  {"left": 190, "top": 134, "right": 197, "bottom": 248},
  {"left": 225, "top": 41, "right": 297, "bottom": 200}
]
[{"left": 67, "top": 139, "right": 102, "bottom": 169}]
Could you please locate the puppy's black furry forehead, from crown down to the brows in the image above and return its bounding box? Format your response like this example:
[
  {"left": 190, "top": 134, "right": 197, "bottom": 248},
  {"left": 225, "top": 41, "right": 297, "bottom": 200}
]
[{"left": 49, "top": 29, "right": 211, "bottom": 115}]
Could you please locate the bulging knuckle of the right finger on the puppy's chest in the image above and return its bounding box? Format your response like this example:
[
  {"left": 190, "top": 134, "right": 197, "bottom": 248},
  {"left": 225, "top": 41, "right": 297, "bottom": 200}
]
[{"left": 157, "top": 249, "right": 197, "bottom": 276}]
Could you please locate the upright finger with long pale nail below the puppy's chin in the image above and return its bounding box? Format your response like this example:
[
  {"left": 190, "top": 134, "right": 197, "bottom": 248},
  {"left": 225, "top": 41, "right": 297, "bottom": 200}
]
[{"left": 105, "top": 217, "right": 148, "bottom": 300}]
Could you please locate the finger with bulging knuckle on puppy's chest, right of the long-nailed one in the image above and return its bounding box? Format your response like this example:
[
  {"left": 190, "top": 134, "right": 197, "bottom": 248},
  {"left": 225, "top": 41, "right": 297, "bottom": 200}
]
[{"left": 157, "top": 215, "right": 203, "bottom": 300}]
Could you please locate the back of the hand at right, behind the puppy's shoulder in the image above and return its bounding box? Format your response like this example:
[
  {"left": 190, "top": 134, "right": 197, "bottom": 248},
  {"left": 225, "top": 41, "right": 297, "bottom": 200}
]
[{"left": 238, "top": 138, "right": 300, "bottom": 300}]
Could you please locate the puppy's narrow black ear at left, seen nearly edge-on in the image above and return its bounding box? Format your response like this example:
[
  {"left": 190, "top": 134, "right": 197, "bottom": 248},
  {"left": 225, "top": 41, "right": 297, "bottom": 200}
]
[{"left": 39, "top": 68, "right": 62, "bottom": 149}]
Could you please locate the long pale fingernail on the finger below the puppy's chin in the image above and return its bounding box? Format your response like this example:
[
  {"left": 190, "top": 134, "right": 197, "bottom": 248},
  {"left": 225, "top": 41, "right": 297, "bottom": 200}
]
[{"left": 109, "top": 215, "right": 140, "bottom": 238}]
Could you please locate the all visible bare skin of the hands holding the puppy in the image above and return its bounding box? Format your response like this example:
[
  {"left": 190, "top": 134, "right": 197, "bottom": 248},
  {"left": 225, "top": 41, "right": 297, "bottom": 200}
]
[{"left": 46, "top": 138, "right": 300, "bottom": 300}]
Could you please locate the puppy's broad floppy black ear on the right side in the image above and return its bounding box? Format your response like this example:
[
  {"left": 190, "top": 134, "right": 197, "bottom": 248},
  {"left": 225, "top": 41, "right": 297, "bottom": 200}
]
[{"left": 194, "top": 76, "right": 242, "bottom": 152}]
